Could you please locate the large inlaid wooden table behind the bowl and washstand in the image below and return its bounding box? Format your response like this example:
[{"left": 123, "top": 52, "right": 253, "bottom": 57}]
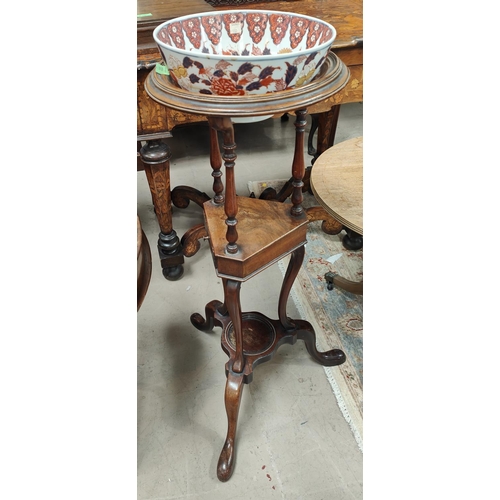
[{"left": 137, "top": 0, "right": 363, "bottom": 280}]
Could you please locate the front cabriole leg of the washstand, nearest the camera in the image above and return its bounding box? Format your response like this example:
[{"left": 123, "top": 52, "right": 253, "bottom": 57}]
[{"left": 217, "top": 370, "right": 243, "bottom": 482}]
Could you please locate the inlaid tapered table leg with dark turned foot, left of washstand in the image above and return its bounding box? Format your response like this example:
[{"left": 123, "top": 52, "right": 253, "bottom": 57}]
[{"left": 140, "top": 139, "right": 184, "bottom": 281}]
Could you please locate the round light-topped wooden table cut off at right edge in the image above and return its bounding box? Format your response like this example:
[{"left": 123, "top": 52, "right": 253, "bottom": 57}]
[{"left": 311, "top": 137, "right": 363, "bottom": 294}]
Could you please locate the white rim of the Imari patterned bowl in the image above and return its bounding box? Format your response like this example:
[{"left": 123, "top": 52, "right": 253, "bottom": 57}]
[{"left": 153, "top": 9, "right": 337, "bottom": 61}]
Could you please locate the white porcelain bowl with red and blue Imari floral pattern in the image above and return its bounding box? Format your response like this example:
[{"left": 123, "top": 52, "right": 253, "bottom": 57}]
[{"left": 153, "top": 10, "right": 337, "bottom": 96}]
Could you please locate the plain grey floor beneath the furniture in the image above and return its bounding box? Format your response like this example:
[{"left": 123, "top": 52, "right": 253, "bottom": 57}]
[{"left": 137, "top": 104, "right": 363, "bottom": 500}]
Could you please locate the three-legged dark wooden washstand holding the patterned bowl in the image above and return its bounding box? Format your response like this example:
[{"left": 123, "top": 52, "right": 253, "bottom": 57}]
[{"left": 145, "top": 49, "right": 349, "bottom": 481}]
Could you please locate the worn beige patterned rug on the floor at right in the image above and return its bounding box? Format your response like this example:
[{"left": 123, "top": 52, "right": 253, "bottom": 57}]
[{"left": 248, "top": 180, "right": 363, "bottom": 451}]
